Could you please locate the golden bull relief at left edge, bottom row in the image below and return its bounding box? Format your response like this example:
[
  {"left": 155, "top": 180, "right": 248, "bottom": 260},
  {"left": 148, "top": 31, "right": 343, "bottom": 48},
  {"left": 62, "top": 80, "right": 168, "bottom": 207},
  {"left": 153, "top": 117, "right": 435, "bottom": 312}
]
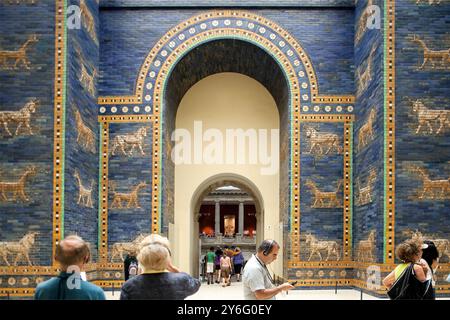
[{"left": 0, "top": 232, "right": 39, "bottom": 266}]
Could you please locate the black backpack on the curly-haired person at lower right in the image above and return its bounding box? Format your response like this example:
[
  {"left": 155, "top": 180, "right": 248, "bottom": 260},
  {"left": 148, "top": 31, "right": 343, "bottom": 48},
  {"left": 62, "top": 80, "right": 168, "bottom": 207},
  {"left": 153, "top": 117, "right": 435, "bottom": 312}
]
[{"left": 387, "top": 263, "right": 434, "bottom": 300}]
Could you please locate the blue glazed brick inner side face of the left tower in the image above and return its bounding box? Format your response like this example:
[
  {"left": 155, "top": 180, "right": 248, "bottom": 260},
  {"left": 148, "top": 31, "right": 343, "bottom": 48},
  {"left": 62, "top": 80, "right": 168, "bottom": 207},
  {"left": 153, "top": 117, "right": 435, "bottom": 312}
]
[{"left": 64, "top": 0, "right": 99, "bottom": 261}]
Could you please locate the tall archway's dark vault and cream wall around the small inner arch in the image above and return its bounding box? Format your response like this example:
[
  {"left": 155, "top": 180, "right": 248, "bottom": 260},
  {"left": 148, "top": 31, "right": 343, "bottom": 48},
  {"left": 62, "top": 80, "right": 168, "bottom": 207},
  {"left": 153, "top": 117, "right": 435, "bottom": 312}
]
[{"left": 162, "top": 39, "right": 290, "bottom": 274}]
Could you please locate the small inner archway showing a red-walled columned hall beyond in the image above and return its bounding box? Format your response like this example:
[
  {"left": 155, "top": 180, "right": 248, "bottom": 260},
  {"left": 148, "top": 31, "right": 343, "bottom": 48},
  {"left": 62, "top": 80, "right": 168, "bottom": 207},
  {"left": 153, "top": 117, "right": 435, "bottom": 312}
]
[{"left": 193, "top": 180, "right": 264, "bottom": 277}]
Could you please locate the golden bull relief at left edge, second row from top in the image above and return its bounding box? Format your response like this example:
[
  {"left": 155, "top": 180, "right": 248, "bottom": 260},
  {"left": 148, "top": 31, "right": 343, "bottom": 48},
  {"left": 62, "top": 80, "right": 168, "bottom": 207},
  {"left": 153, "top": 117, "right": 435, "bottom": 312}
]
[{"left": 0, "top": 98, "right": 39, "bottom": 137}]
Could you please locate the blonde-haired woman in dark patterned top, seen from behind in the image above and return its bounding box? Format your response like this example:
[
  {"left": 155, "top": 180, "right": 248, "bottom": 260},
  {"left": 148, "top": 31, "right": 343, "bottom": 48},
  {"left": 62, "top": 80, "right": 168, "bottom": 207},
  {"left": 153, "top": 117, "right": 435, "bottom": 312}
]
[{"left": 120, "top": 235, "right": 200, "bottom": 300}]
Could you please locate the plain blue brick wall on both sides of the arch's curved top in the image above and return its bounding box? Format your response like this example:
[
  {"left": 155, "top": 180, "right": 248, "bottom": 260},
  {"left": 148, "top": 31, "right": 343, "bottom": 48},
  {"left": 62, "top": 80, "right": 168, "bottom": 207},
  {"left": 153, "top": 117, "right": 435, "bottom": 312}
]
[{"left": 99, "top": 8, "right": 354, "bottom": 96}]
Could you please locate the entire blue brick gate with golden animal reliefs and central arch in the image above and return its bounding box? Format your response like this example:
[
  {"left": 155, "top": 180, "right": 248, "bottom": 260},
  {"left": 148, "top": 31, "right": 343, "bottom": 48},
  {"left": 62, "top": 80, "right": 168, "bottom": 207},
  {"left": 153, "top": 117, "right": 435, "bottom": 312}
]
[{"left": 0, "top": 0, "right": 450, "bottom": 299}]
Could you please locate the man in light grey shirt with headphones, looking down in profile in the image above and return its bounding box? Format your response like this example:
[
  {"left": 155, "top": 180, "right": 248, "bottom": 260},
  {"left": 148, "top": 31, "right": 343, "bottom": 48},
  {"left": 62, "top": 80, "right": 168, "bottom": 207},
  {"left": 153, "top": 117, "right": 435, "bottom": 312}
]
[{"left": 242, "top": 240, "right": 294, "bottom": 300}]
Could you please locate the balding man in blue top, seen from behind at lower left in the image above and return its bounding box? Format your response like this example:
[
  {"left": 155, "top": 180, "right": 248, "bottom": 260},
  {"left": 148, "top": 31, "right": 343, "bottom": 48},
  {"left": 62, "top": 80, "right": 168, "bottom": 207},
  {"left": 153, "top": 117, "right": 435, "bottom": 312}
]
[{"left": 34, "top": 235, "right": 106, "bottom": 300}]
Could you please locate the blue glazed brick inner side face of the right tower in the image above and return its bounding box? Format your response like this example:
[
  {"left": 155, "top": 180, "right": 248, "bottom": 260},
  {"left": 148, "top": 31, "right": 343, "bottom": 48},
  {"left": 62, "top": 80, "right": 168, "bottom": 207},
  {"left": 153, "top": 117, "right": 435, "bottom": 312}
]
[{"left": 352, "top": 0, "right": 384, "bottom": 263}]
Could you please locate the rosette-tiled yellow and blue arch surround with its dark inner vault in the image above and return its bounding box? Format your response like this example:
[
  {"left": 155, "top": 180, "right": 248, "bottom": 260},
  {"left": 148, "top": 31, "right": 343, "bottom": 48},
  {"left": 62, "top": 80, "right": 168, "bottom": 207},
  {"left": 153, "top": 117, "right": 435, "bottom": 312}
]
[{"left": 98, "top": 10, "right": 354, "bottom": 284}]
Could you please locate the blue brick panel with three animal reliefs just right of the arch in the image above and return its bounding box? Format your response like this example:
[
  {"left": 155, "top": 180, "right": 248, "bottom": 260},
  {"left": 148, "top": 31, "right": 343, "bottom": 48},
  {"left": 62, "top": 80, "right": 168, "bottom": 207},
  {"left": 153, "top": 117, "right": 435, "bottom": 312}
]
[{"left": 300, "top": 123, "right": 344, "bottom": 261}]
